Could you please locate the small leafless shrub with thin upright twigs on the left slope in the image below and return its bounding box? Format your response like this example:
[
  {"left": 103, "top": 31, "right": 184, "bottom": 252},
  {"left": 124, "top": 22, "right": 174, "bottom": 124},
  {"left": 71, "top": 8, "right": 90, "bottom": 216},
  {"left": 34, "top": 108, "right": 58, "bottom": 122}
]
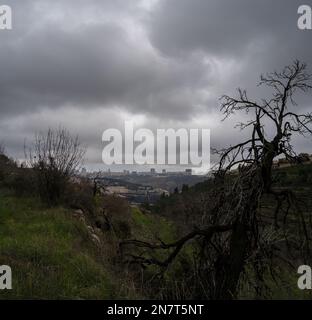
[{"left": 28, "top": 128, "right": 85, "bottom": 205}]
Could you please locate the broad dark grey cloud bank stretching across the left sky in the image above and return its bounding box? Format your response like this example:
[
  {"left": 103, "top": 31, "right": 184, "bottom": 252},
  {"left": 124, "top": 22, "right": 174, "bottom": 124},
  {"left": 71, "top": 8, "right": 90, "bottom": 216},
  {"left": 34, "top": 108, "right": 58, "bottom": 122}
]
[{"left": 0, "top": 1, "right": 212, "bottom": 120}]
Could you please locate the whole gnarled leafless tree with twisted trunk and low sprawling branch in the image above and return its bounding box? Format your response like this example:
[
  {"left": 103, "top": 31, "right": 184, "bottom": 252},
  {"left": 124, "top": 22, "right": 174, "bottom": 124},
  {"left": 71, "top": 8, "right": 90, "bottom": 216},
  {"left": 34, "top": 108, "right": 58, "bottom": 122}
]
[{"left": 121, "top": 61, "right": 312, "bottom": 299}]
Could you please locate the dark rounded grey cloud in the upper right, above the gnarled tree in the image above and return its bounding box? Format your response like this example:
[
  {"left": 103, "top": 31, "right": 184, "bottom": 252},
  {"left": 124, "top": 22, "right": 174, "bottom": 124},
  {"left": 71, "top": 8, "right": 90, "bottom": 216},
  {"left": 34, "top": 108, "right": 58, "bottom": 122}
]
[{"left": 147, "top": 0, "right": 312, "bottom": 99}]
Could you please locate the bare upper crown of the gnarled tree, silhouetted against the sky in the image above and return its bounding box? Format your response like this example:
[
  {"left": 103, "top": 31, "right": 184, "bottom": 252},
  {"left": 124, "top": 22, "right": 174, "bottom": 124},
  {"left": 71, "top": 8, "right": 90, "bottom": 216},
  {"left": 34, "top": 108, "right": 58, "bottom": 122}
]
[{"left": 220, "top": 61, "right": 312, "bottom": 191}]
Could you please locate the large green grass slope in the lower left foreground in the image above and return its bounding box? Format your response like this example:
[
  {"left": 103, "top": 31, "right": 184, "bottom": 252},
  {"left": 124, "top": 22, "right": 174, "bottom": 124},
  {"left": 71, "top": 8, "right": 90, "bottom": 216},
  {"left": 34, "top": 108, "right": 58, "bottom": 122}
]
[{"left": 0, "top": 191, "right": 114, "bottom": 299}]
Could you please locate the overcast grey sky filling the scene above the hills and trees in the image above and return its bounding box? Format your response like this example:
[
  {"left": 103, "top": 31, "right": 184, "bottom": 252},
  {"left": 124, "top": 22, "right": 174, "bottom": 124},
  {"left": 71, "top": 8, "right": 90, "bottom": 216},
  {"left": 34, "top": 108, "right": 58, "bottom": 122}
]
[{"left": 0, "top": 0, "right": 312, "bottom": 172}]
